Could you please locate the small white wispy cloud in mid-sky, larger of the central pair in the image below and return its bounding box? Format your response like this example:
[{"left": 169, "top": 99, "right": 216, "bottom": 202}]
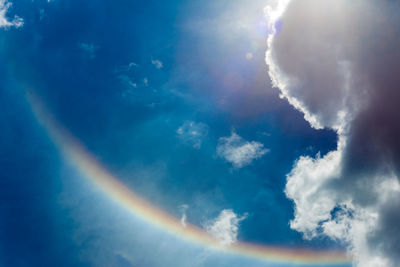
[{"left": 217, "top": 132, "right": 269, "bottom": 168}]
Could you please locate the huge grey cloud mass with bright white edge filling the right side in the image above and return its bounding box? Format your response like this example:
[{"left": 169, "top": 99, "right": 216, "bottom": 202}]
[{"left": 266, "top": 0, "right": 400, "bottom": 267}]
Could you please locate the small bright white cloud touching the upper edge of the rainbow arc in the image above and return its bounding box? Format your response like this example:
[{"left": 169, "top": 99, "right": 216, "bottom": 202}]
[{"left": 204, "top": 209, "right": 247, "bottom": 246}]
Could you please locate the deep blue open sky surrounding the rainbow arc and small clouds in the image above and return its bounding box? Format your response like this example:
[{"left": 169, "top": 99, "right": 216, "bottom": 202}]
[{"left": 6, "top": 0, "right": 396, "bottom": 267}]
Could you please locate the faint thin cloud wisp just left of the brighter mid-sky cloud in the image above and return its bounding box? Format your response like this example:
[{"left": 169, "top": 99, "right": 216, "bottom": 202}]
[{"left": 176, "top": 121, "right": 209, "bottom": 149}]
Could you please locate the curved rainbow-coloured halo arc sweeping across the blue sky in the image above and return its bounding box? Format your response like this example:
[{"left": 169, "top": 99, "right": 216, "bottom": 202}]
[{"left": 27, "top": 93, "right": 351, "bottom": 266}]
